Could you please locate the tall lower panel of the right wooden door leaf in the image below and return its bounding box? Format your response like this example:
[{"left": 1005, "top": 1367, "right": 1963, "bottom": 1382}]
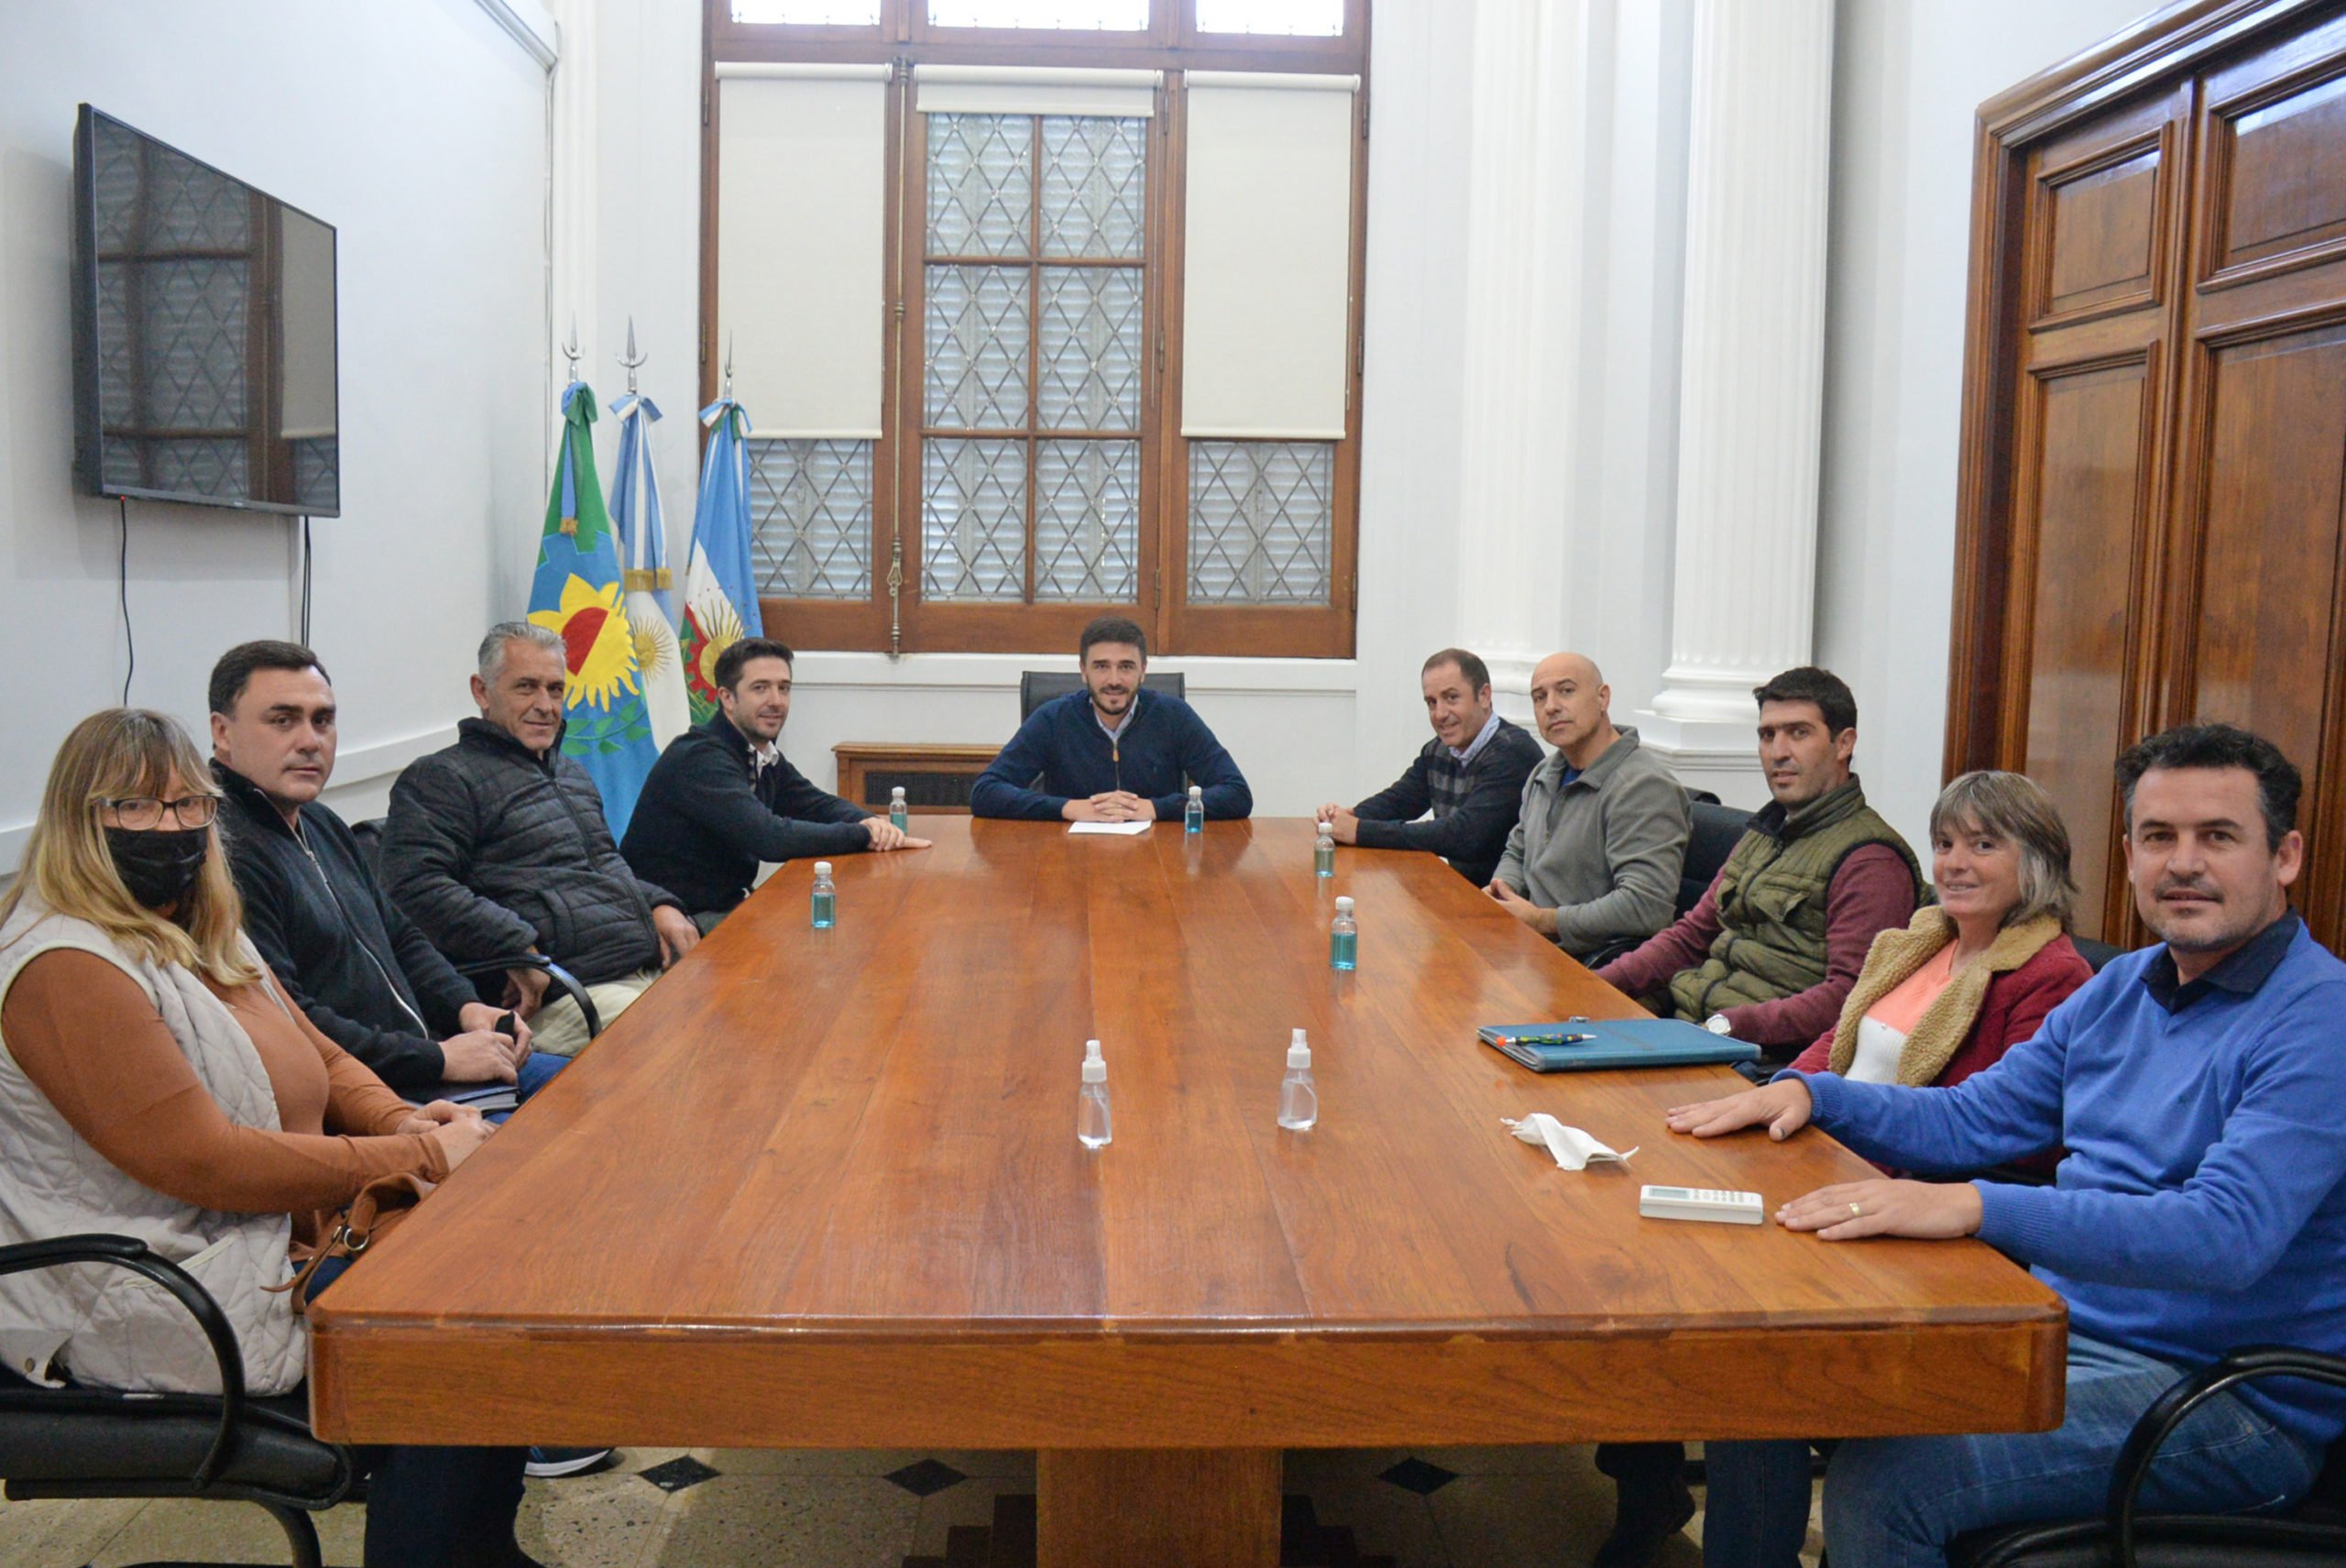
[{"left": 2187, "top": 323, "right": 2346, "bottom": 821}]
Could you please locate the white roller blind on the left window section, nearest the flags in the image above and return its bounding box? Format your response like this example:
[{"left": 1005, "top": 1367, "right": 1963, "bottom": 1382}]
[{"left": 711, "top": 63, "right": 887, "bottom": 439}]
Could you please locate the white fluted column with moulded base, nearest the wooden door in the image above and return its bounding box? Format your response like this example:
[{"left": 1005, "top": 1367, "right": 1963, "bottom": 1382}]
[{"left": 1638, "top": 0, "right": 1832, "bottom": 806}]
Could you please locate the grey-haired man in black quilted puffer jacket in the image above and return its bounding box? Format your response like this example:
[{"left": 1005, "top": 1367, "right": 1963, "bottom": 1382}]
[{"left": 382, "top": 620, "right": 701, "bottom": 1057}]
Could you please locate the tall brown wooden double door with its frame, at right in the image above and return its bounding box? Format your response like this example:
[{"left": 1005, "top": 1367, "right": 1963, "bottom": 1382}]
[{"left": 1947, "top": 0, "right": 2346, "bottom": 946}]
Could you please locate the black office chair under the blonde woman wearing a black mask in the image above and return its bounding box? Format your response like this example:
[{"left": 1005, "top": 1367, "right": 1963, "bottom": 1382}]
[{"left": 0, "top": 1234, "right": 356, "bottom": 1568}]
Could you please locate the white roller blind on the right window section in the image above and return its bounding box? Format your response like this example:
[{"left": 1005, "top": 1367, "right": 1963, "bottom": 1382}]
[{"left": 1180, "top": 71, "right": 1358, "bottom": 442}]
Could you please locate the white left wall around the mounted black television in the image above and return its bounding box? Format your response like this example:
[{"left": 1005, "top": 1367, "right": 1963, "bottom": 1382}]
[{"left": 0, "top": 0, "right": 551, "bottom": 873}]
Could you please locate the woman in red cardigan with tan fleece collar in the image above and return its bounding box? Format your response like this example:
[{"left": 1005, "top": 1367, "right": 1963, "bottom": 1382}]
[{"left": 1671, "top": 773, "right": 2093, "bottom": 1568}]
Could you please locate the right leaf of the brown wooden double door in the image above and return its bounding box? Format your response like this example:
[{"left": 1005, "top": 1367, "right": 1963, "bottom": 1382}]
[{"left": 2161, "top": 16, "right": 2346, "bottom": 948}]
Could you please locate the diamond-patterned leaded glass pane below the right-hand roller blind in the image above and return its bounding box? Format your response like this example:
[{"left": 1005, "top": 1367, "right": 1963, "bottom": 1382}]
[{"left": 1189, "top": 442, "right": 1335, "bottom": 603}]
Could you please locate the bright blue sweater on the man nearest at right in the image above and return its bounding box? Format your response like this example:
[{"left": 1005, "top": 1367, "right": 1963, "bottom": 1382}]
[{"left": 1806, "top": 913, "right": 2346, "bottom": 1443}]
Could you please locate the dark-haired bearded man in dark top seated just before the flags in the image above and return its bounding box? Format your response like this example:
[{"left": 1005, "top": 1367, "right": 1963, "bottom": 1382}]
[{"left": 619, "top": 636, "right": 929, "bottom": 932}]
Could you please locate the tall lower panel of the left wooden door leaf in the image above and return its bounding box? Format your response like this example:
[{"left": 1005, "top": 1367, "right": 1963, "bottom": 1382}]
[{"left": 2008, "top": 355, "right": 2154, "bottom": 937}]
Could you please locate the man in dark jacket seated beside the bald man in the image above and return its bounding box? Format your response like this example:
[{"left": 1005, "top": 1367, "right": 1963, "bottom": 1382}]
[{"left": 1319, "top": 648, "right": 1539, "bottom": 887}]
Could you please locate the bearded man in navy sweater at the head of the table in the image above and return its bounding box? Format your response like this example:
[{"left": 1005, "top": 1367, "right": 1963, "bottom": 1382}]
[{"left": 969, "top": 615, "right": 1255, "bottom": 821}]
